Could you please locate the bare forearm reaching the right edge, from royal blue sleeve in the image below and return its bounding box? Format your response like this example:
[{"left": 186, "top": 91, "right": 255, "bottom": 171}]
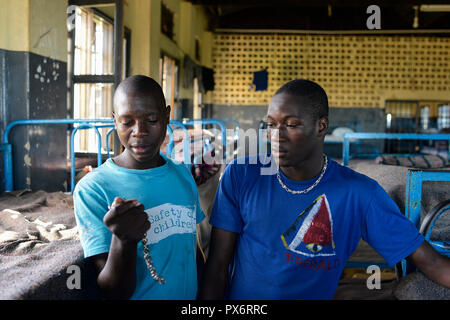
[{"left": 406, "top": 241, "right": 450, "bottom": 289}]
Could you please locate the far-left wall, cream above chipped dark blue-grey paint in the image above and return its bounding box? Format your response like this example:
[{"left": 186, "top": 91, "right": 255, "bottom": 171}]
[{"left": 0, "top": 0, "right": 67, "bottom": 192}]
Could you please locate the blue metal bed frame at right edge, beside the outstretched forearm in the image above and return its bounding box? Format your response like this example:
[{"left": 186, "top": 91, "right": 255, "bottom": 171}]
[{"left": 401, "top": 169, "right": 450, "bottom": 276}]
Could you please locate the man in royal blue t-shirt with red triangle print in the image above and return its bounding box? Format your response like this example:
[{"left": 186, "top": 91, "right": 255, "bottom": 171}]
[{"left": 199, "top": 80, "right": 450, "bottom": 300}]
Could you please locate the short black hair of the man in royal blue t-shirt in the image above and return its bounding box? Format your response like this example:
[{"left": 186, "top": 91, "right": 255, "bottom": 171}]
[{"left": 275, "top": 79, "right": 328, "bottom": 121}]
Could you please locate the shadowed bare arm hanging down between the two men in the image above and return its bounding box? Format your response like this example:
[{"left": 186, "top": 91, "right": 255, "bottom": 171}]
[{"left": 198, "top": 227, "right": 237, "bottom": 300}]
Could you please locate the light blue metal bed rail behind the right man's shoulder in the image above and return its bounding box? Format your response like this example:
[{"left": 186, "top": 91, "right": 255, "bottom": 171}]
[{"left": 342, "top": 132, "right": 450, "bottom": 166}]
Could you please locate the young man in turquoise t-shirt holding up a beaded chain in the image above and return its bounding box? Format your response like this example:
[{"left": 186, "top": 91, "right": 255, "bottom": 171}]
[{"left": 74, "top": 76, "right": 204, "bottom": 300}]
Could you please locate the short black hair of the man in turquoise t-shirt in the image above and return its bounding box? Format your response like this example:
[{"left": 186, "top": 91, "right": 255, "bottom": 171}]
[{"left": 114, "top": 75, "right": 166, "bottom": 112}]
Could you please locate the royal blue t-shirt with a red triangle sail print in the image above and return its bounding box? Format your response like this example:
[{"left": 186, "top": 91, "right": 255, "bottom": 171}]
[{"left": 210, "top": 158, "right": 424, "bottom": 300}]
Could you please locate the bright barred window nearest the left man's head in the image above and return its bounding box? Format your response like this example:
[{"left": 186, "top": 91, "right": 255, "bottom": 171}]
[{"left": 73, "top": 7, "right": 114, "bottom": 153}]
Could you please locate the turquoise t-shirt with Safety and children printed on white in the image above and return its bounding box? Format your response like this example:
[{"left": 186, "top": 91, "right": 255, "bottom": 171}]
[{"left": 74, "top": 154, "right": 204, "bottom": 300}]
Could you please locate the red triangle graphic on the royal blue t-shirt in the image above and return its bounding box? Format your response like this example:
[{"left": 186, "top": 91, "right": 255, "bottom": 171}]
[{"left": 303, "top": 198, "right": 332, "bottom": 246}]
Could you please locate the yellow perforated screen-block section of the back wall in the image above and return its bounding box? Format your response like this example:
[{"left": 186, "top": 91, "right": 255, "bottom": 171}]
[{"left": 213, "top": 33, "right": 450, "bottom": 108}]
